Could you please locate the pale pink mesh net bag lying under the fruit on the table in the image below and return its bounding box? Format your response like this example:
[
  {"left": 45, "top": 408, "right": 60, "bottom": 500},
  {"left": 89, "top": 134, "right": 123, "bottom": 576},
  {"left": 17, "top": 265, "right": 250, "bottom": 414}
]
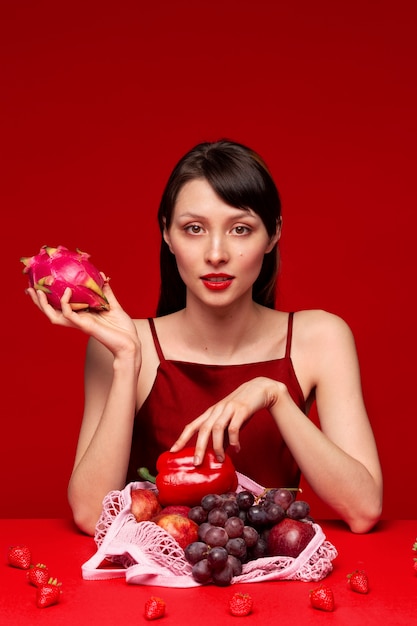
[{"left": 82, "top": 473, "right": 337, "bottom": 587}]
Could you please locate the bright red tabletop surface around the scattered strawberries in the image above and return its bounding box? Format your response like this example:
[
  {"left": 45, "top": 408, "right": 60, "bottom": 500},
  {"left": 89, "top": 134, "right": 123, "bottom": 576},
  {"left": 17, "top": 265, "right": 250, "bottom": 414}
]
[{"left": 0, "top": 519, "right": 417, "bottom": 626}]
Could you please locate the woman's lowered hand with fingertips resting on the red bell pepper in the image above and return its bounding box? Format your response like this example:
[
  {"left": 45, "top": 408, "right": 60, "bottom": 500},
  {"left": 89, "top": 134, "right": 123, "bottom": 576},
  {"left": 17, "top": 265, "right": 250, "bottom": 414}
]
[{"left": 171, "top": 377, "right": 288, "bottom": 465}]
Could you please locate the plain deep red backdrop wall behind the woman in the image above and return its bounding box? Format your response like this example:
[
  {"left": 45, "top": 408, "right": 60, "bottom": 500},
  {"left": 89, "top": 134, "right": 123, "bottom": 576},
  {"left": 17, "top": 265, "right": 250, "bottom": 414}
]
[{"left": 0, "top": 0, "right": 417, "bottom": 518}]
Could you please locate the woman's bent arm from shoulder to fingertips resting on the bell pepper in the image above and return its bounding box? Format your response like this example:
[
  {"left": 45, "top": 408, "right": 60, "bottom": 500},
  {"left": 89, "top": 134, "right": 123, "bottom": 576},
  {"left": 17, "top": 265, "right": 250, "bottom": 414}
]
[{"left": 169, "top": 312, "right": 382, "bottom": 533}]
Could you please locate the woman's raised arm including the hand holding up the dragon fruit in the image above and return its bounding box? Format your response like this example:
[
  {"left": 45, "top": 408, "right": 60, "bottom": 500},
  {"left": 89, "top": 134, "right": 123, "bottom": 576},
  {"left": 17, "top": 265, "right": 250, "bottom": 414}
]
[{"left": 29, "top": 285, "right": 141, "bottom": 534}]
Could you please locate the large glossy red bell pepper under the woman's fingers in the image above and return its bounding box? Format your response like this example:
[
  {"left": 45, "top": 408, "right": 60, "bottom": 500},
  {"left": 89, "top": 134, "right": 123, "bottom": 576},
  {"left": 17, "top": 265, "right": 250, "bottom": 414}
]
[{"left": 140, "top": 447, "right": 238, "bottom": 506}]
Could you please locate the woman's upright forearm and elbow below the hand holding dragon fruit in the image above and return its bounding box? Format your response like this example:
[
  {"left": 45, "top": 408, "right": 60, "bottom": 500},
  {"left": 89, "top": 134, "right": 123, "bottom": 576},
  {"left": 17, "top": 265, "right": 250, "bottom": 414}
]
[{"left": 68, "top": 339, "right": 139, "bottom": 534}]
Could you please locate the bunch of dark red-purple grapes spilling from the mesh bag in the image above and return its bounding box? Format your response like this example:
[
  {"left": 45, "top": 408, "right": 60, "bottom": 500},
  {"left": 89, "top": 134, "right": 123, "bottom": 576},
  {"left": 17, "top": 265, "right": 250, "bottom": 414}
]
[{"left": 184, "top": 488, "right": 312, "bottom": 586}]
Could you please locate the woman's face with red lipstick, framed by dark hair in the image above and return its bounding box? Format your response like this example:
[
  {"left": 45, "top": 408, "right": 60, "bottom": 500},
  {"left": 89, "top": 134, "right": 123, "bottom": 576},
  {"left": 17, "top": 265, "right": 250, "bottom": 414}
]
[{"left": 164, "top": 178, "right": 280, "bottom": 306}]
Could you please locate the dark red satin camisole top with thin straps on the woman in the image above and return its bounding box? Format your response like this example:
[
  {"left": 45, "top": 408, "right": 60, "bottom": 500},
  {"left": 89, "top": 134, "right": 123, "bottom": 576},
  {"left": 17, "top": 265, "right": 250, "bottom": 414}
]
[{"left": 127, "top": 313, "right": 306, "bottom": 487}]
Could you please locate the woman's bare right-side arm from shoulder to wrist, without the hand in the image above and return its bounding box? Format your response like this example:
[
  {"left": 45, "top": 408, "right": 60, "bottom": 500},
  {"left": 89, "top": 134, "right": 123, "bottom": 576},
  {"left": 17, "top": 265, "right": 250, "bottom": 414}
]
[{"left": 279, "top": 311, "right": 383, "bottom": 532}]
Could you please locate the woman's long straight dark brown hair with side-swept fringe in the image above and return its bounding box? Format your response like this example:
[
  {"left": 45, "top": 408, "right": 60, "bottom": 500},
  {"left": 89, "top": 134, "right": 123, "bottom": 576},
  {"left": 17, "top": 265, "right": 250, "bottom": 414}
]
[{"left": 157, "top": 139, "right": 281, "bottom": 316}]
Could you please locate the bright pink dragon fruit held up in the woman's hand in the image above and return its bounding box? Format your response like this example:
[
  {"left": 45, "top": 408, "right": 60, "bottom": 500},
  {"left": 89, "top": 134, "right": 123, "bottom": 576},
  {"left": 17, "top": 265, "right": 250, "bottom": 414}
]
[{"left": 20, "top": 246, "right": 110, "bottom": 311}]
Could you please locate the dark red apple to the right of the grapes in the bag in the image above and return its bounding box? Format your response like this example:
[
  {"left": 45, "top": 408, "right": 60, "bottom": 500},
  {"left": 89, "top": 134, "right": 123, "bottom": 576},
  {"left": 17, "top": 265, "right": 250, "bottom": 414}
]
[{"left": 268, "top": 517, "right": 316, "bottom": 558}]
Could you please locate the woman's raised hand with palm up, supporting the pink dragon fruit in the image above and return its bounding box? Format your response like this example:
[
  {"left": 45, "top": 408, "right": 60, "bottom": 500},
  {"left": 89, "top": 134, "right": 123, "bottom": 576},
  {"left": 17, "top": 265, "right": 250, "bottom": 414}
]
[{"left": 27, "top": 280, "right": 139, "bottom": 356}]
